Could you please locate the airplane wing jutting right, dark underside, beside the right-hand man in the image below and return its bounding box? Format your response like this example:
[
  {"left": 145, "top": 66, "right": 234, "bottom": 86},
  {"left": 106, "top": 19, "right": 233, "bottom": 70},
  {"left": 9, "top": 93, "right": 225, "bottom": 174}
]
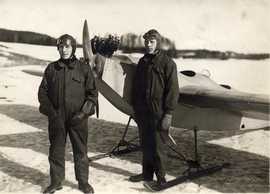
[{"left": 179, "top": 86, "right": 269, "bottom": 120}]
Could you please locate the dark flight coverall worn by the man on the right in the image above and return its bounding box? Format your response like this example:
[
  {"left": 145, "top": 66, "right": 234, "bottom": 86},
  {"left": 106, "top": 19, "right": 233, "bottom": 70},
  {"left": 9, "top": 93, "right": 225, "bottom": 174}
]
[{"left": 133, "top": 51, "right": 179, "bottom": 181}]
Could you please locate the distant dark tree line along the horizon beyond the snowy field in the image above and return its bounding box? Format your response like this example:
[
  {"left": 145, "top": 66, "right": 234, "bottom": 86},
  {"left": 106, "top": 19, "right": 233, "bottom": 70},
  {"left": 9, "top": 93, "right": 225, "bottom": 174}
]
[{"left": 0, "top": 28, "right": 270, "bottom": 60}]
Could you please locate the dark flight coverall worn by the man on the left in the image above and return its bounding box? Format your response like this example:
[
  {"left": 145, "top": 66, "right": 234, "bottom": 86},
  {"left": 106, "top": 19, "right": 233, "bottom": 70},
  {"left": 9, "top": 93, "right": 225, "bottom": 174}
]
[{"left": 38, "top": 57, "right": 98, "bottom": 183}]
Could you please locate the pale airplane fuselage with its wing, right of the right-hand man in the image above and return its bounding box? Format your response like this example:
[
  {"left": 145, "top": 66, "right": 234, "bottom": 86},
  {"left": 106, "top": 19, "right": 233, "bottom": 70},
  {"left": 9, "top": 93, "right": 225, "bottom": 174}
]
[{"left": 173, "top": 71, "right": 270, "bottom": 130}]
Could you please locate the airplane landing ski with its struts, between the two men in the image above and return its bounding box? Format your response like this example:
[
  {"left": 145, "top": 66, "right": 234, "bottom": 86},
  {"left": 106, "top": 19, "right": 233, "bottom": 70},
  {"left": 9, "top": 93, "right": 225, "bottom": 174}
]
[{"left": 88, "top": 116, "right": 141, "bottom": 162}]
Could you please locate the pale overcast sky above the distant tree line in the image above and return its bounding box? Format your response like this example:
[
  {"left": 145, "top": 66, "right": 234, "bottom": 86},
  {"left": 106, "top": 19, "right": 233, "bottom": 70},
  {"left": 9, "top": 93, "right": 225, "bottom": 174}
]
[{"left": 0, "top": 0, "right": 270, "bottom": 52}]
